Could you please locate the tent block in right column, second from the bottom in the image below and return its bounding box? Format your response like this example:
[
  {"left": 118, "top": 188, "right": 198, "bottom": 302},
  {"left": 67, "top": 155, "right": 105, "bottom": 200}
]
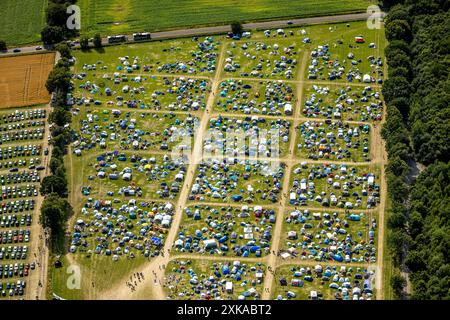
[{"left": 283, "top": 209, "right": 377, "bottom": 263}]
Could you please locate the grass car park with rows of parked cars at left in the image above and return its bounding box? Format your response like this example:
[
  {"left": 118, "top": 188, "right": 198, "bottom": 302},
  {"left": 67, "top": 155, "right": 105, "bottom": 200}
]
[{"left": 0, "top": 107, "right": 48, "bottom": 299}]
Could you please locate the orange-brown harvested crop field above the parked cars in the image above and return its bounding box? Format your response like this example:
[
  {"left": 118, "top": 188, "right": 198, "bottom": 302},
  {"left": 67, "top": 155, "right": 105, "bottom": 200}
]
[{"left": 0, "top": 53, "right": 55, "bottom": 108}]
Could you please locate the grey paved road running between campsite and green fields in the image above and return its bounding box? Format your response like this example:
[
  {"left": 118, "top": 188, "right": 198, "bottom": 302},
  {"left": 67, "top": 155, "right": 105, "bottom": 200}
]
[{"left": 0, "top": 12, "right": 385, "bottom": 57}]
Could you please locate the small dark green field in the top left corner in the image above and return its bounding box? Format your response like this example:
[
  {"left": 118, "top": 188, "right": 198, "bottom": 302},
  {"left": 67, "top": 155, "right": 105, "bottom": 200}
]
[{"left": 0, "top": 0, "right": 47, "bottom": 46}]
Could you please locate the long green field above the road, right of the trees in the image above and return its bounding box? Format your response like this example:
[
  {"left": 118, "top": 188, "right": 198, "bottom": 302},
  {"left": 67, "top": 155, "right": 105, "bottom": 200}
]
[{"left": 78, "top": 0, "right": 372, "bottom": 35}]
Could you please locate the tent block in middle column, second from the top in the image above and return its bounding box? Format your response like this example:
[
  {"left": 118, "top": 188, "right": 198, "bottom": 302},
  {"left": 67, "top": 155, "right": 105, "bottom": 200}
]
[{"left": 215, "top": 80, "right": 295, "bottom": 116}]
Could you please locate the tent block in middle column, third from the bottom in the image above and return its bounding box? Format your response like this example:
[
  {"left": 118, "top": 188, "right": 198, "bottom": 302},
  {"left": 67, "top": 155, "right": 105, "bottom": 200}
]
[{"left": 189, "top": 158, "right": 284, "bottom": 203}]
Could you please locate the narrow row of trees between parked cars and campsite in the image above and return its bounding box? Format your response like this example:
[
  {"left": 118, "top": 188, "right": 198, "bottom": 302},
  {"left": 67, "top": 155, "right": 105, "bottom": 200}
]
[{"left": 40, "top": 43, "right": 73, "bottom": 252}]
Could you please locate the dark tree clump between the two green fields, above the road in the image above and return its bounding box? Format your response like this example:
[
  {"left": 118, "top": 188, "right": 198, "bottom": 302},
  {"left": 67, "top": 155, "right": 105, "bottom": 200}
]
[{"left": 41, "top": 0, "right": 78, "bottom": 45}]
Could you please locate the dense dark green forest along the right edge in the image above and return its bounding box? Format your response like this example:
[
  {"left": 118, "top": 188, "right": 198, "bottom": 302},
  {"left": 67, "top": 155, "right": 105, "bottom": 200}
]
[{"left": 382, "top": 0, "right": 450, "bottom": 299}]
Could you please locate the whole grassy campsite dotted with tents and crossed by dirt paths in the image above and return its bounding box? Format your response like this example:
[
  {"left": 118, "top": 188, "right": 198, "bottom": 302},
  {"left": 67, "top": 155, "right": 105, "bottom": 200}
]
[{"left": 56, "top": 20, "right": 386, "bottom": 300}]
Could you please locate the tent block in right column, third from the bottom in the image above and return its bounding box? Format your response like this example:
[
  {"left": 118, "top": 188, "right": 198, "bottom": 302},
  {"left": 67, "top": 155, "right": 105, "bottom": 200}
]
[{"left": 289, "top": 162, "right": 380, "bottom": 209}]
